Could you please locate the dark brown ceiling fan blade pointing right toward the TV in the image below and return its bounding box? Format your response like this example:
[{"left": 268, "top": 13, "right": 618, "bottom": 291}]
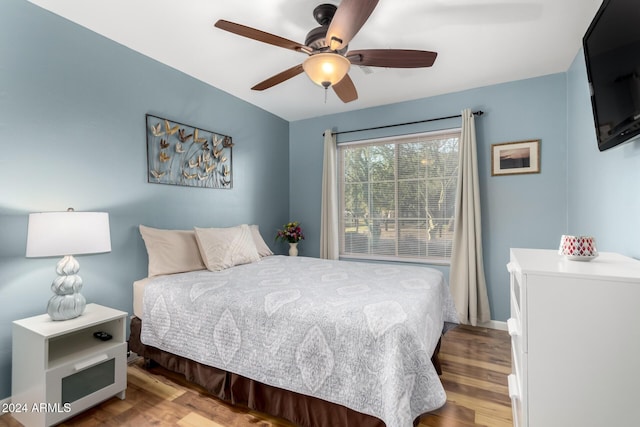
[{"left": 346, "top": 49, "right": 438, "bottom": 68}]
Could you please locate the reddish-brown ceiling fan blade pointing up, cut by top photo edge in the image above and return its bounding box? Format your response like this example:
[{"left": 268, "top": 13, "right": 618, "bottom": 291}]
[{"left": 326, "top": 0, "right": 378, "bottom": 50}]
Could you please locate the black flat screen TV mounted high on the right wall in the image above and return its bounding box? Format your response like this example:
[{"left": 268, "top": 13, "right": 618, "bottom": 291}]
[{"left": 583, "top": 0, "right": 640, "bottom": 151}]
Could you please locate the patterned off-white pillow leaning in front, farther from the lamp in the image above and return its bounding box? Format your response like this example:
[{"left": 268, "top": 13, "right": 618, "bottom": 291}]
[{"left": 195, "top": 224, "right": 260, "bottom": 271}]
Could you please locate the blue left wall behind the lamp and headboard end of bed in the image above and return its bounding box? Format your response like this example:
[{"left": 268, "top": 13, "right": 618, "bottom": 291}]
[{"left": 0, "top": 0, "right": 289, "bottom": 399}]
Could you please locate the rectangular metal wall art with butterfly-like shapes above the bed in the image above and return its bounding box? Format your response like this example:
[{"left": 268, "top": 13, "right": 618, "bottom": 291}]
[{"left": 146, "top": 114, "right": 233, "bottom": 189}]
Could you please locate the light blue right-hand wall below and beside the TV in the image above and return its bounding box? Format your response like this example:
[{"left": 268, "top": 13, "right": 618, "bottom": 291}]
[{"left": 567, "top": 52, "right": 640, "bottom": 258}]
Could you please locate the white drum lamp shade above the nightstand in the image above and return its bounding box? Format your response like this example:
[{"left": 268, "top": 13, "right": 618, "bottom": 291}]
[{"left": 26, "top": 211, "right": 111, "bottom": 257}]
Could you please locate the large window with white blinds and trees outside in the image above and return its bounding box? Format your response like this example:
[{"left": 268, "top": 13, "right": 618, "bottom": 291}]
[{"left": 338, "top": 129, "right": 460, "bottom": 264}]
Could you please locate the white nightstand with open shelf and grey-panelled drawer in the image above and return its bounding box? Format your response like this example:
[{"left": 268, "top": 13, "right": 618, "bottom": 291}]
[{"left": 11, "top": 304, "right": 127, "bottom": 426}]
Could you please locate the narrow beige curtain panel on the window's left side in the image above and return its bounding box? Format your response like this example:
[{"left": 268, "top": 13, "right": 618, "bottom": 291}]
[{"left": 320, "top": 129, "right": 340, "bottom": 259}]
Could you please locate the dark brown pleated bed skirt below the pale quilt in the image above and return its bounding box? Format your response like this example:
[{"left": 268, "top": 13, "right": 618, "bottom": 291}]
[{"left": 129, "top": 316, "right": 440, "bottom": 427}]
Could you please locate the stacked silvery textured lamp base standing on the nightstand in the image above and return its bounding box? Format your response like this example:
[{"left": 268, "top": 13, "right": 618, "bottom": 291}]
[{"left": 47, "top": 255, "right": 87, "bottom": 320}]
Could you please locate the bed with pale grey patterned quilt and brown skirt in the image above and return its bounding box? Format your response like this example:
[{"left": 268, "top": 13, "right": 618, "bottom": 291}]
[{"left": 129, "top": 228, "right": 457, "bottom": 427}]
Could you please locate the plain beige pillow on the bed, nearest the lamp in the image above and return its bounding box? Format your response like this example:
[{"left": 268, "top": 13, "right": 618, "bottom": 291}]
[{"left": 139, "top": 225, "right": 206, "bottom": 277}]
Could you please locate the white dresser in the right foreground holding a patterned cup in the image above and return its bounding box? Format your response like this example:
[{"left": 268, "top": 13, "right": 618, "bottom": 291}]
[{"left": 507, "top": 249, "right": 640, "bottom": 427}]
